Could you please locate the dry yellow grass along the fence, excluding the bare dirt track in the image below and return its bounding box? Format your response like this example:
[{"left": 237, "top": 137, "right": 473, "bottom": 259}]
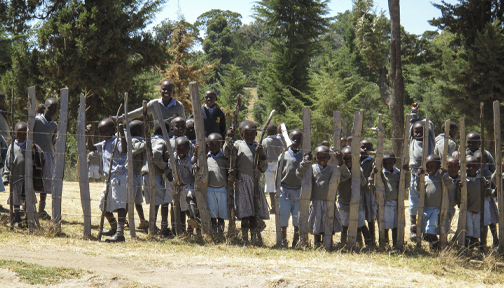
[{"left": 0, "top": 182, "right": 504, "bottom": 287}]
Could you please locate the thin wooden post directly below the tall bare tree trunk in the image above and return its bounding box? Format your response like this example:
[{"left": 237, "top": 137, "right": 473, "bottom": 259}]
[{"left": 396, "top": 114, "right": 413, "bottom": 249}]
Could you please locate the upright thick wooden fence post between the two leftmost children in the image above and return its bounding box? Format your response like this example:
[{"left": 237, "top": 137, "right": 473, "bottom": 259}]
[{"left": 25, "top": 86, "right": 40, "bottom": 231}]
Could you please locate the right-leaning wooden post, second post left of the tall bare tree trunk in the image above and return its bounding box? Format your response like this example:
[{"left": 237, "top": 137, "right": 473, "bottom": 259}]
[{"left": 347, "top": 109, "right": 366, "bottom": 247}]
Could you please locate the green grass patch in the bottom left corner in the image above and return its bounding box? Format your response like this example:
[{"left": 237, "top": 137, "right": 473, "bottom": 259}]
[{"left": 0, "top": 260, "right": 84, "bottom": 285}]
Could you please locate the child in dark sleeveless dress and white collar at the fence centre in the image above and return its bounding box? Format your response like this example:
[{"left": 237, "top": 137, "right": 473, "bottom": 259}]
[{"left": 224, "top": 120, "right": 269, "bottom": 245}]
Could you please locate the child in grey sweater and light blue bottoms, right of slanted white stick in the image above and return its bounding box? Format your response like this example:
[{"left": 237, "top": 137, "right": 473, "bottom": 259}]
[{"left": 275, "top": 129, "right": 303, "bottom": 248}]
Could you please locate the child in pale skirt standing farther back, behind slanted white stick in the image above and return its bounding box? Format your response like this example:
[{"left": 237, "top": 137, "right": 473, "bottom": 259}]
[{"left": 262, "top": 124, "right": 284, "bottom": 214}]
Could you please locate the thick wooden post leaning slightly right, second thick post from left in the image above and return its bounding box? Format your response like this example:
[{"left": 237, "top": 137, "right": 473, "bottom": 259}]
[{"left": 52, "top": 88, "right": 68, "bottom": 229}]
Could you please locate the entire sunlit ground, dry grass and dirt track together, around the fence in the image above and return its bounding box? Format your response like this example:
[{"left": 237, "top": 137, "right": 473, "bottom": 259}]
[{"left": 0, "top": 182, "right": 504, "bottom": 287}]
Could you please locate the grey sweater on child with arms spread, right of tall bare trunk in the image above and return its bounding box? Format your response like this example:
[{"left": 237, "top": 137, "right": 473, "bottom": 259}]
[{"left": 415, "top": 172, "right": 453, "bottom": 208}]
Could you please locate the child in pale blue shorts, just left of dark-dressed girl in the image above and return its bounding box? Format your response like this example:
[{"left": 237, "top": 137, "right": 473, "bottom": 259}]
[{"left": 200, "top": 133, "right": 229, "bottom": 238}]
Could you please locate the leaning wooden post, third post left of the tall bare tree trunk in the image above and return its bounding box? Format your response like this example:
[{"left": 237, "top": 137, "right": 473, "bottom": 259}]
[{"left": 324, "top": 111, "right": 342, "bottom": 251}]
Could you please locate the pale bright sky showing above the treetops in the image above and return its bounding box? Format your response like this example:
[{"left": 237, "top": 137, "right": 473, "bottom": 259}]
[{"left": 153, "top": 0, "right": 459, "bottom": 35}]
